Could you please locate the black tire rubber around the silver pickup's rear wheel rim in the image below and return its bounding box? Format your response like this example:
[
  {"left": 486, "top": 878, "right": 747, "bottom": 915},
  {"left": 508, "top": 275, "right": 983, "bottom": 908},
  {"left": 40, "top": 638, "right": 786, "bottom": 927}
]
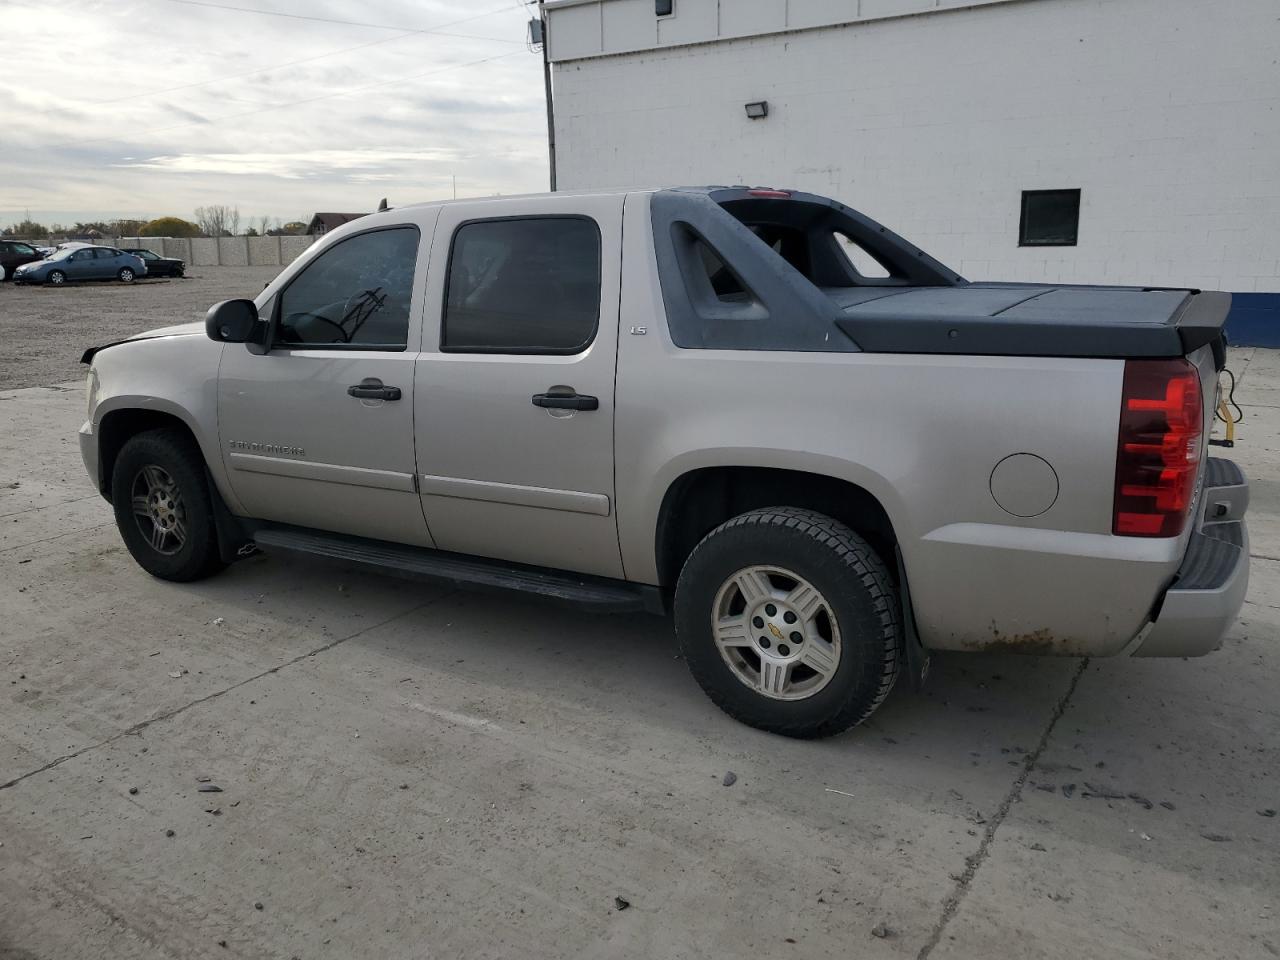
[{"left": 675, "top": 507, "right": 901, "bottom": 739}]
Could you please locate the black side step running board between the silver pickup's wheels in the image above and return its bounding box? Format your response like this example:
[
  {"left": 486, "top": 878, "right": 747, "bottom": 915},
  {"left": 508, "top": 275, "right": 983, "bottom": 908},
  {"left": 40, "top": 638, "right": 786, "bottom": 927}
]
[{"left": 253, "top": 527, "right": 663, "bottom": 613}]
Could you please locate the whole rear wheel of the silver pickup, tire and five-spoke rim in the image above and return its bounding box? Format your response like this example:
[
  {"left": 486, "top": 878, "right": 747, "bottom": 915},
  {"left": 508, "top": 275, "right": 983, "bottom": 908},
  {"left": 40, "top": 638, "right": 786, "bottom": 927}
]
[{"left": 675, "top": 507, "right": 901, "bottom": 737}]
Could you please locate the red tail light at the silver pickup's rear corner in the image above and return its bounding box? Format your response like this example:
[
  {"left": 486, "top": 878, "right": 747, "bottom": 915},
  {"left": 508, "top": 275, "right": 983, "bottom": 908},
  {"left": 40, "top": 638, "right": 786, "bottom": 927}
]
[{"left": 1111, "top": 360, "right": 1204, "bottom": 536}]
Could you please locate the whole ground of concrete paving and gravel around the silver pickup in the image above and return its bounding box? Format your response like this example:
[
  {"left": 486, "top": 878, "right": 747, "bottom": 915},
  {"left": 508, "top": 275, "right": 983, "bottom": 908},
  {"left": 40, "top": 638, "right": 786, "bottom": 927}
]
[{"left": 0, "top": 268, "right": 1280, "bottom": 960}]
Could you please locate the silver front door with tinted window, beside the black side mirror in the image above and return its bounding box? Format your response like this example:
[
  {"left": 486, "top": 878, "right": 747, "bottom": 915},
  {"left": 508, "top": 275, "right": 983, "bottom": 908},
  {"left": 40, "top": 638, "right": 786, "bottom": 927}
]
[{"left": 218, "top": 220, "right": 434, "bottom": 547}]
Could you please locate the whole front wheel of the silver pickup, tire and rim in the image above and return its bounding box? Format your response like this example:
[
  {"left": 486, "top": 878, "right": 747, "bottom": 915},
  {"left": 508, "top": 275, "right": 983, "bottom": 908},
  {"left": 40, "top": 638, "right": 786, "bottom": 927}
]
[{"left": 111, "top": 430, "right": 224, "bottom": 581}]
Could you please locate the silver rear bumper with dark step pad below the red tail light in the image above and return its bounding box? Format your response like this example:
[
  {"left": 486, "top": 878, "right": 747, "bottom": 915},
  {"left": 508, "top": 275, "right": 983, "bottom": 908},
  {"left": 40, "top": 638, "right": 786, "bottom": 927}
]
[{"left": 1133, "top": 458, "right": 1249, "bottom": 657}]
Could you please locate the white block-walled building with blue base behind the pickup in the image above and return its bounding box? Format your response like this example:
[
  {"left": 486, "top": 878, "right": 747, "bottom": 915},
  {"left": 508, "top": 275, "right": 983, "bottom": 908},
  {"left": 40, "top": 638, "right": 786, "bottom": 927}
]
[{"left": 545, "top": 0, "right": 1280, "bottom": 346}]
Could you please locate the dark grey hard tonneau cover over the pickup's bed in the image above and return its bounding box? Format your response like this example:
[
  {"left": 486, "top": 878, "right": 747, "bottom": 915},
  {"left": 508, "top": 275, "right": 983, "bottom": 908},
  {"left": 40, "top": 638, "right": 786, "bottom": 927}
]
[{"left": 823, "top": 283, "right": 1231, "bottom": 357}]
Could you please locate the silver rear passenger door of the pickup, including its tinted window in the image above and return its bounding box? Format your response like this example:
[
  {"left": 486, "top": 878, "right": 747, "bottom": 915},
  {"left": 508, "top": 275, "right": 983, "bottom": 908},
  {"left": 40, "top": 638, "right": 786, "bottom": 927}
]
[{"left": 413, "top": 196, "right": 622, "bottom": 577}]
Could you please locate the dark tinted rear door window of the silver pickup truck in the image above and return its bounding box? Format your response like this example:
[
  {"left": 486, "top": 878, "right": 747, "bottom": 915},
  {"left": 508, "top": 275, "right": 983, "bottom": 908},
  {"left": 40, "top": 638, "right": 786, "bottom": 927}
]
[{"left": 440, "top": 216, "right": 600, "bottom": 353}]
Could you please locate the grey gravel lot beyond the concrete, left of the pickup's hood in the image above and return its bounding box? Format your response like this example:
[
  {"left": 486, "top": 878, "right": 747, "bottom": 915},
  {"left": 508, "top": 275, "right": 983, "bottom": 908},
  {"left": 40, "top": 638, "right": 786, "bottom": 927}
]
[{"left": 0, "top": 266, "right": 283, "bottom": 390}]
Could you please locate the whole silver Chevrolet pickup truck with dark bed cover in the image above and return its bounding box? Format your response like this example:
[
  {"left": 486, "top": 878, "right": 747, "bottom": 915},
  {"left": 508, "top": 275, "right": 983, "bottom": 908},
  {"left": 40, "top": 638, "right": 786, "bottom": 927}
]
[{"left": 79, "top": 187, "right": 1248, "bottom": 737}]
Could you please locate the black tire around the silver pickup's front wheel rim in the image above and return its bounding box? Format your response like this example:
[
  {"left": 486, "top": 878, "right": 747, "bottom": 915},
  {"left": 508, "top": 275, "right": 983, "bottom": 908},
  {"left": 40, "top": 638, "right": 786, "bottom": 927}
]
[{"left": 111, "top": 430, "right": 225, "bottom": 582}]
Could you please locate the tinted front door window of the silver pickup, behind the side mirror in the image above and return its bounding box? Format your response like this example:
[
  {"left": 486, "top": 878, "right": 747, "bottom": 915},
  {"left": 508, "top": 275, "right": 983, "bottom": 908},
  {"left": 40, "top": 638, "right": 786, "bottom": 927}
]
[{"left": 275, "top": 227, "right": 419, "bottom": 349}]
